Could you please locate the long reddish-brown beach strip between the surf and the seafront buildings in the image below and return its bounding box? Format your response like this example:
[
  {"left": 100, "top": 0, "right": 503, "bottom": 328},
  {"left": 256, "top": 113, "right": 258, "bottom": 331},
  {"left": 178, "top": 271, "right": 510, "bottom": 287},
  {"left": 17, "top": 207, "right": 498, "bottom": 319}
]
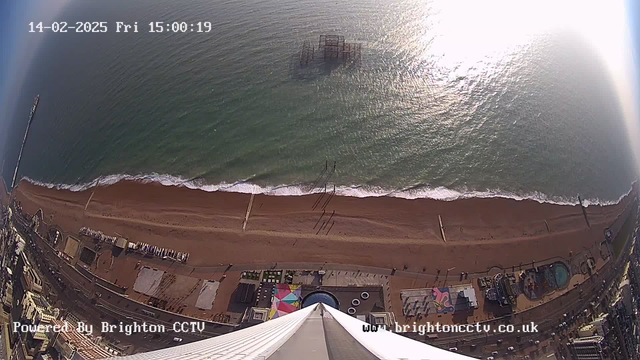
[{"left": 14, "top": 181, "right": 631, "bottom": 273}]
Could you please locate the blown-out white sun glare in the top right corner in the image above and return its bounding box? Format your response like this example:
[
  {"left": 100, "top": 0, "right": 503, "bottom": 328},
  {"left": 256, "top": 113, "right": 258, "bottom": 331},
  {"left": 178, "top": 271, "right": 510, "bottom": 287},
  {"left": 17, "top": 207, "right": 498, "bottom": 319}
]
[{"left": 417, "top": 0, "right": 640, "bottom": 174}]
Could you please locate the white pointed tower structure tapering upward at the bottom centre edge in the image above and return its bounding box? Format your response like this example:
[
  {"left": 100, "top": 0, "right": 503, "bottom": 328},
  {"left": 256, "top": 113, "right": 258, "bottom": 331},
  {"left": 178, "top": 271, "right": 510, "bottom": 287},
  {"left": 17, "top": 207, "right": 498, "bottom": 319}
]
[{"left": 107, "top": 303, "right": 471, "bottom": 360}]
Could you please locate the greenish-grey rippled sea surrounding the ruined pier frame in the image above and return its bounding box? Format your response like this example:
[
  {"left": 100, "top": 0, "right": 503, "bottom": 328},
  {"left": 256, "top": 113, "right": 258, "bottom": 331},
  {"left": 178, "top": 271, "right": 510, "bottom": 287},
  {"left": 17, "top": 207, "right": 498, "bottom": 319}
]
[{"left": 3, "top": 0, "right": 635, "bottom": 203}]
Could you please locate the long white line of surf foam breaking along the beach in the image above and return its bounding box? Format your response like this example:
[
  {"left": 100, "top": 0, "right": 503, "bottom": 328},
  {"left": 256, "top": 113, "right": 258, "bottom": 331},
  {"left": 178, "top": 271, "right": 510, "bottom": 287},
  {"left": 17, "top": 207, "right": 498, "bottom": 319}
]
[{"left": 22, "top": 173, "right": 631, "bottom": 206}]
